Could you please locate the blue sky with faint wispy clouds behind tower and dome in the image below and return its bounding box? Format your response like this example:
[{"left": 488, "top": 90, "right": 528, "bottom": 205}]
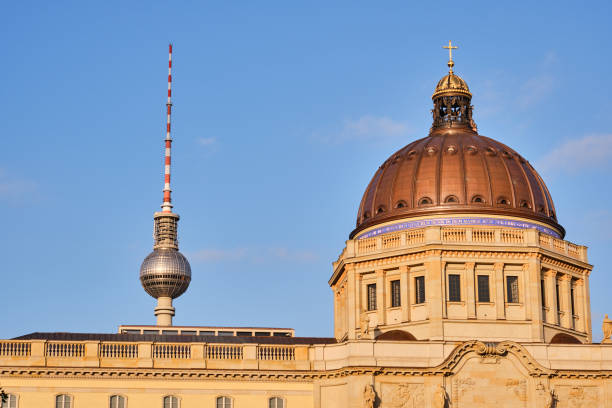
[{"left": 0, "top": 1, "right": 612, "bottom": 341}]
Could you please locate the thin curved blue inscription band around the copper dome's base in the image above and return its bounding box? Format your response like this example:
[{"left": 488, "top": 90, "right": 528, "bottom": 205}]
[{"left": 357, "top": 217, "right": 561, "bottom": 239}]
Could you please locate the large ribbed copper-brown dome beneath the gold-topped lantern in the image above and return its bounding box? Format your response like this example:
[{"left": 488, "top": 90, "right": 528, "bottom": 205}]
[{"left": 351, "top": 127, "right": 565, "bottom": 237}]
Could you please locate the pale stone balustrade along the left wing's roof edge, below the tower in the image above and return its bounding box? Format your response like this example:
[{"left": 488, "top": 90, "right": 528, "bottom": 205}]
[{"left": 0, "top": 340, "right": 310, "bottom": 369}]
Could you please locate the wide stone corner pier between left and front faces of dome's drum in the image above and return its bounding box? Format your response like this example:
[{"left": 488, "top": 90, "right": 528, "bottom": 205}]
[{"left": 424, "top": 251, "right": 446, "bottom": 340}]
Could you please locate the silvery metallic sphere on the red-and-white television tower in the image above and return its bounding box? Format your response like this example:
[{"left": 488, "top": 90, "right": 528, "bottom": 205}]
[{"left": 140, "top": 249, "right": 191, "bottom": 299}]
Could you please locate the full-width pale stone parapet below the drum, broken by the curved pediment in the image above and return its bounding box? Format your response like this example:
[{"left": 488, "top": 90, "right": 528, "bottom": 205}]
[{"left": 0, "top": 340, "right": 612, "bottom": 371}]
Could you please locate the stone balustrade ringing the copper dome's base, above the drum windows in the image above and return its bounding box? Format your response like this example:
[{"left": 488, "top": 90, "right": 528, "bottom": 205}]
[{"left": 339, "top": 226, "right": 587, "bottom": 262}]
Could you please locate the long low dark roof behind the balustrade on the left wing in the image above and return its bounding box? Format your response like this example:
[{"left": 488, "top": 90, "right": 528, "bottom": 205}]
[{"left": 12, "top": 332, "right": 336, "bottom": 345}]
